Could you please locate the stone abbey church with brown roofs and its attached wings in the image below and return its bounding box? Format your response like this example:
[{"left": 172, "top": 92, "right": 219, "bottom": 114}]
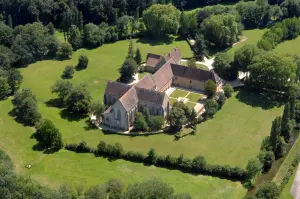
[{"left": 102, "top": 48, "right": 217, "bottom": 131}]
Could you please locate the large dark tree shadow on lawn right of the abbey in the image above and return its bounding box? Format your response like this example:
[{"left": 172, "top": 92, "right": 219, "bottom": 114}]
[{"left": 236, "top": 88, "right": 284, "bottom": 110}]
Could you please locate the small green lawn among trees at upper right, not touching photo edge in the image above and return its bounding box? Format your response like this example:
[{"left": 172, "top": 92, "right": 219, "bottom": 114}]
[{"left": 227, "top": 29, "right": 267, "bottom": 56}]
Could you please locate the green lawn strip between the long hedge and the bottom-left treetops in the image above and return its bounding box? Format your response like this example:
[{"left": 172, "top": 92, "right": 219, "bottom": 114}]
[{"left": 0, "top": 100, "right": 245, "bottom": 199}]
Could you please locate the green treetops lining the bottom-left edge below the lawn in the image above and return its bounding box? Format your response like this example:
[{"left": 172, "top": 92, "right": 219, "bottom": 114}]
[{"left": 0, "top": 150, "right": 191, "bottom": 199}]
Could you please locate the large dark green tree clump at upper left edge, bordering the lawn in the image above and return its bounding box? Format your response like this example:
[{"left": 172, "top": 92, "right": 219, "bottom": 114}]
[{"left": 0, "top": 22, "right": 72, "bottom": 68}]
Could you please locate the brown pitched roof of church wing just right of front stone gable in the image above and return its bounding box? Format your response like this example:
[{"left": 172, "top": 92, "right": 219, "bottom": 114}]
[{"left": 136, "top": 88, "right": 166, "bottom": 106}]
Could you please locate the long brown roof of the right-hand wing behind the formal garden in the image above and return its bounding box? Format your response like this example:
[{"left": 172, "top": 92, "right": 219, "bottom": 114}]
[{"left": 171, "top": 64, "right": 216, "bottom": 82}]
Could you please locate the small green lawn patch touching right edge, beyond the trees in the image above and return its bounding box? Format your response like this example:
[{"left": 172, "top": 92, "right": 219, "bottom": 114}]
[{"left": 274, "top": 37, "right": 300, "bottom": 55}]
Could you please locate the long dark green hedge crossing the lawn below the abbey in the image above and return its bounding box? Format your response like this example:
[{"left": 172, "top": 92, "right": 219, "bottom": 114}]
[{"left": 65, "top": 141, "right": 246, "bottom": 182}]
